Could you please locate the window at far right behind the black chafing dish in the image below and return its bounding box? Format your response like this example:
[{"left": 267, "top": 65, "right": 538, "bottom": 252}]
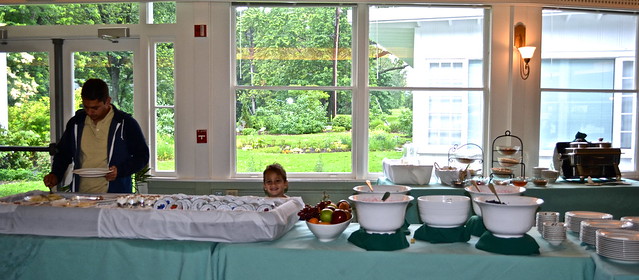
[{"left": 539, "top": 10, "right": 637, "bottom": 171}]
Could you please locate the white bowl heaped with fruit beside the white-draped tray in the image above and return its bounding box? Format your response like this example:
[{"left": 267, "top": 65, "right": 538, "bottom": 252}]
[{"left": 297, "top": 200, "right": 353, "bottom": 242}]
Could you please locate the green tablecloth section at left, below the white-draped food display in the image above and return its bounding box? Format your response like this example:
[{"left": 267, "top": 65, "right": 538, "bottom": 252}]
[{"left": 0, "top": 234, "right": 216, "bottom": 280}]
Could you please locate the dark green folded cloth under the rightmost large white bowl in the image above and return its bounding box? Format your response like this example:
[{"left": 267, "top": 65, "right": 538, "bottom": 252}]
[{"left": 475, "top": 231, "right": 539, "bottom": 255}]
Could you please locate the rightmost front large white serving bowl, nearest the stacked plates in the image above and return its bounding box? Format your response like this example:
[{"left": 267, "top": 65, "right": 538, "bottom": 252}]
[{"left": 473, "top": 196, "right": 544, "bottom": 238}]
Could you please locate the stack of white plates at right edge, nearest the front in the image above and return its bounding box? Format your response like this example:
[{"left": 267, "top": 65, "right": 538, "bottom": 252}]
[{"left": 596, "top": 229, "right": 639, "bottom": 263}]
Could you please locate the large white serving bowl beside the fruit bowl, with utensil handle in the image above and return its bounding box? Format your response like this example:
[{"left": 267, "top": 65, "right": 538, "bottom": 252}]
[{"left": 348, "top": 193, "right": 414, "bottom": 234}]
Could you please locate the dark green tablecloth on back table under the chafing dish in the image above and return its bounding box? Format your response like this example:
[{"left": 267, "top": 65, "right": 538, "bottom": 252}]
[{"left": 377, "top": 177, "right": 639, "bottom": 224}]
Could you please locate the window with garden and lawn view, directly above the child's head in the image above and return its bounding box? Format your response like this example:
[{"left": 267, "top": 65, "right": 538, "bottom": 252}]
[{"left": 235, "top": 5, "right": 354, "bottom": 174}]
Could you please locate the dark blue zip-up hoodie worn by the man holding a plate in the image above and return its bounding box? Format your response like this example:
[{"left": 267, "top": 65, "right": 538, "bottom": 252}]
[{"left": 51, "top": 104, "right": 149, "bottom": 193}]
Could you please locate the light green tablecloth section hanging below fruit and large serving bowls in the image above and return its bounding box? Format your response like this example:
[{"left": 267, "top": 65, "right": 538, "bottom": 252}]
[{"left": 213, "top": 223, "right": 595, "bottom": 280}]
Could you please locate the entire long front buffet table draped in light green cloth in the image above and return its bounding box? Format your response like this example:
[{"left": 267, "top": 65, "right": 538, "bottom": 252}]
[{"left": 0, "top": 222, "right": 639, "bottom": 280}]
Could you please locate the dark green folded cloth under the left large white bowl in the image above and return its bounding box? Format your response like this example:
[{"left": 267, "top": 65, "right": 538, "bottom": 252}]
[{"left": 348, "top": 228, "right": 409, "bottom": 251}]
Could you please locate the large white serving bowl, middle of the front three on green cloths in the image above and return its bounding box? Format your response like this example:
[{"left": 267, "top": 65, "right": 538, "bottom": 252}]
[{"left": 417, "top": 195, "right": 470, "bottom": 228}]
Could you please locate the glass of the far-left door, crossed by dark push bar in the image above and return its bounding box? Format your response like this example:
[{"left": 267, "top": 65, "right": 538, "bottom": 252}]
[{"left": 0, "top": 51, "right": 51, "bottom": 178}]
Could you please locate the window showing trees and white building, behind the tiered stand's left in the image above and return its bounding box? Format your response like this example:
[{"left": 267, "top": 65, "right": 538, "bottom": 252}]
[{"left": 369, "top": 6, "right": 485, "bottom": 172}]
